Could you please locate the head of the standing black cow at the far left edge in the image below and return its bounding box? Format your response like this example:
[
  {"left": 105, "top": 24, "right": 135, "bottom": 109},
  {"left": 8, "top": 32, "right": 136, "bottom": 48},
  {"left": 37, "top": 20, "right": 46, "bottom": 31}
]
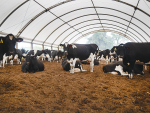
[{"left": 4, "top": 34, "right": 23, "bottom": 55}]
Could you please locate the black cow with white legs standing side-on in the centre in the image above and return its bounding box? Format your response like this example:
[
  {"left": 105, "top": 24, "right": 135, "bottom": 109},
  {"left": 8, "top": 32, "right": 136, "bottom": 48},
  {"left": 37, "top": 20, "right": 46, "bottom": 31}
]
[{"left": 60, "top": 42, "right": 98, "bottom": 73}]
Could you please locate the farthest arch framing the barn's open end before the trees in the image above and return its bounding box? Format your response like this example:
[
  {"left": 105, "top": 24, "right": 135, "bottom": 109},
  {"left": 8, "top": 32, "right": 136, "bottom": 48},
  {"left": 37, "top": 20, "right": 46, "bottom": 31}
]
[{"left": 73, "top": 29, "right": 135, "bottom": 43}]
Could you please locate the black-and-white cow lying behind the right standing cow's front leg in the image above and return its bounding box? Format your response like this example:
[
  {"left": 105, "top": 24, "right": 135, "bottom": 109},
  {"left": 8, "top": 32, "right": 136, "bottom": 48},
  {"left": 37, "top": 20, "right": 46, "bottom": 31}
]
[{"left": 103, "top": 61, "right": 144, "bottom": 75}]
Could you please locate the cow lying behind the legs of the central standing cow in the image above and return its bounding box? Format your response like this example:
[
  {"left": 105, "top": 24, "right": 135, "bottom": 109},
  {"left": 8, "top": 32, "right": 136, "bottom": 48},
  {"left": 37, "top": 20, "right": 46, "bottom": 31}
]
[{"left": 62, "top": 58, "right": 82, "bottom": 72}]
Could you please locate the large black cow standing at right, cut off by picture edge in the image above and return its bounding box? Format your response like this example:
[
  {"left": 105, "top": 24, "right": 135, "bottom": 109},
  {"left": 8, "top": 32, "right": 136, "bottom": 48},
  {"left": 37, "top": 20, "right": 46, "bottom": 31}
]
[{"left": 117, "top": 42, "right": 150, "bottom": 78}]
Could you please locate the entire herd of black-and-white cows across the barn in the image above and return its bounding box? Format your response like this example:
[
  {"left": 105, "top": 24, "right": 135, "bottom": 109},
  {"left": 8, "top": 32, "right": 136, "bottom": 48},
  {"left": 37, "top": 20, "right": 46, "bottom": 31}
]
[{"left": 0, "top": 34, "right": 150, "bottom": 78}]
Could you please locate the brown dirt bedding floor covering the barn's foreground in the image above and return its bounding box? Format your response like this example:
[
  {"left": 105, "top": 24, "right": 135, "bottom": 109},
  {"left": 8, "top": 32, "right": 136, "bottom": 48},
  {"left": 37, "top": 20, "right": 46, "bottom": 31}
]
[{"left": 0, "top": 61, "right": 150, "bottom": 113}]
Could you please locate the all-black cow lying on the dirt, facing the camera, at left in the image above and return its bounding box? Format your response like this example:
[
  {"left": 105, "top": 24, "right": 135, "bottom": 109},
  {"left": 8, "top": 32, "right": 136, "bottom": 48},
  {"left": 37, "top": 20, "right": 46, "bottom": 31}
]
[{"left": 22, "top": 55, "right": 44, "bottom": 73}]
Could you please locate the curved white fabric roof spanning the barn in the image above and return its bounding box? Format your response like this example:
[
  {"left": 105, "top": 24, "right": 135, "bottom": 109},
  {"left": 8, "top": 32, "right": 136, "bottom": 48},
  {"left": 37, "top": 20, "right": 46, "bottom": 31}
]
[{"left": 0, "top": 0, "right": 150, "bottom": 46}]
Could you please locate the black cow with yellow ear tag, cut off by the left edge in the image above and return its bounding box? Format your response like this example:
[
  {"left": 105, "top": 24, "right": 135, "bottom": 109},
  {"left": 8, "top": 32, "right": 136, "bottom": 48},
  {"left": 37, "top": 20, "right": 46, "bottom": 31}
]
[{"left": 0, "top": 34, "right": 23, "bottom": 67}]
